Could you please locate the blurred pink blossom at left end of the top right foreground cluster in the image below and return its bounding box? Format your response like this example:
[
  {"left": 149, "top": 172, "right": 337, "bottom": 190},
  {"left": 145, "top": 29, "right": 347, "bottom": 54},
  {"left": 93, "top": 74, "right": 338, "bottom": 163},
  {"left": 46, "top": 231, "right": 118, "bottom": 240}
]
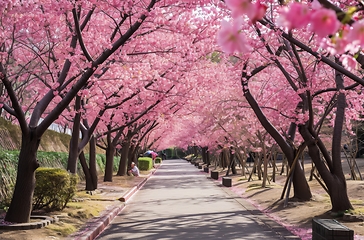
[{"left": 279, "top": 2, "right": 310, "bottom": 30}]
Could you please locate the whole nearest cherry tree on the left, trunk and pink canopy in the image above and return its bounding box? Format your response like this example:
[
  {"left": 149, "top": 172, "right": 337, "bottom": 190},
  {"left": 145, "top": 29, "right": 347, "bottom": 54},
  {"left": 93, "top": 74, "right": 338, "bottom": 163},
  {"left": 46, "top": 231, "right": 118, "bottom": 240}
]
[{"left": 0, "top": 0, "right": 218, "bottom": 222}]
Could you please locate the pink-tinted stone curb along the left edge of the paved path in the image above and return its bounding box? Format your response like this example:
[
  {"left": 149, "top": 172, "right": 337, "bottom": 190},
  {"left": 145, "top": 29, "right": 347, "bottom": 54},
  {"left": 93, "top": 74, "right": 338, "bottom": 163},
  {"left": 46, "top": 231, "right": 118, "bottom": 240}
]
[{"left": 67, "top": 165, "right": 160, "bottom": 240}]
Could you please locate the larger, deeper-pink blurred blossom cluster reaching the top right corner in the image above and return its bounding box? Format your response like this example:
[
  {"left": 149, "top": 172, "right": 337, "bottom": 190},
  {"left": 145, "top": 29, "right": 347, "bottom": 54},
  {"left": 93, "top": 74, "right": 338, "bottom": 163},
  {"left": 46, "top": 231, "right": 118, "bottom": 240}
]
[{"left": 277, "top": 0, "right": 364, "bottom": 70}]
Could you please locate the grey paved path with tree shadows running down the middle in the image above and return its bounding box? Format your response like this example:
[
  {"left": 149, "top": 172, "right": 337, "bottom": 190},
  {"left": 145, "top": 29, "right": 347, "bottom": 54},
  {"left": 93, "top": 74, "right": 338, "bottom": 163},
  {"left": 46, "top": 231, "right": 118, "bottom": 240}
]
[{"left": 97, "top": 160, "right": 299, "bottom": 240}]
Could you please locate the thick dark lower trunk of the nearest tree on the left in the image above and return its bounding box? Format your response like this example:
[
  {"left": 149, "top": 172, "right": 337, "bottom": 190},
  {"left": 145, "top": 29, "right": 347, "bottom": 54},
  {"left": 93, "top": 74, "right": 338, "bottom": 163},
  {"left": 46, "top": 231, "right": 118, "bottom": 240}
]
[{"left": 5, "top": 129, "right": 40, "bottom": 223}]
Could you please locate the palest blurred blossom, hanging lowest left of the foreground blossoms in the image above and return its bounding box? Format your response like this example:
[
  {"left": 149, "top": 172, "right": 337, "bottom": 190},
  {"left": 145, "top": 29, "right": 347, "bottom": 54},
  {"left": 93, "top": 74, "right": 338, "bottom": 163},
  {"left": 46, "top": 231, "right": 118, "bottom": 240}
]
[{"left": 217, "top": 21, "right": 250, "bottom": 53}]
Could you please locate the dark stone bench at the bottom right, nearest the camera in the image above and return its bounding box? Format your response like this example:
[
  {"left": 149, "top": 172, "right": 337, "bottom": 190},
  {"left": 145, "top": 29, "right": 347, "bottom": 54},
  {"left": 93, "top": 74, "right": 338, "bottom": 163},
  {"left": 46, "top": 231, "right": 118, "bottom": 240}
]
[{"left": 312, "top": 219, "right": 354, "bottom": 240}]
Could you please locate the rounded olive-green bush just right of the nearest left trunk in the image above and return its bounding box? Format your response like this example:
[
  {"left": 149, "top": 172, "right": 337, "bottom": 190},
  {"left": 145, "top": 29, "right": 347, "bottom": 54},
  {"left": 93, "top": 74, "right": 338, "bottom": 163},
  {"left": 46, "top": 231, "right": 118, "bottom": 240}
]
[{"left": 33, "top": 168, "right": 78, "bottom": 211}]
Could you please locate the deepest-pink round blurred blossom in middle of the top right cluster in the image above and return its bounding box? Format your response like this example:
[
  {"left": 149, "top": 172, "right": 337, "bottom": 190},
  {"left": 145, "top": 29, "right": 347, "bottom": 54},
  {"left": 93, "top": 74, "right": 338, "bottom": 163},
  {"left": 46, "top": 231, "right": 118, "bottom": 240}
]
[{"left": 311, "top": 8, "right": 340, "bottom": 38}]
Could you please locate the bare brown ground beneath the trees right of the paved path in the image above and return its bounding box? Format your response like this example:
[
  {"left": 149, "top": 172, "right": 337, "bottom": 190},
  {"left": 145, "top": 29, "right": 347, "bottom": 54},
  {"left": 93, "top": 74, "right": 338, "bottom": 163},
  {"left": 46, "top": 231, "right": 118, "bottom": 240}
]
[{"left": 220, "top": 163, "right": 364, "bottom": 240}]
